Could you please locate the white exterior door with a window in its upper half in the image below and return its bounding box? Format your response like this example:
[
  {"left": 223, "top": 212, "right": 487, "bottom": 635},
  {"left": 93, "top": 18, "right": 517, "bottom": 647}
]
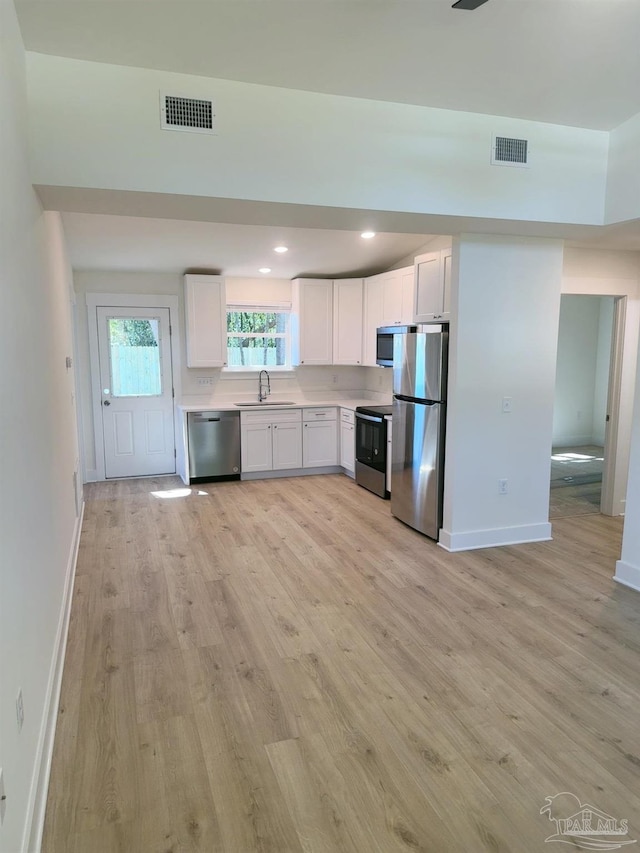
[{"left": 96, "top": 307, "right": 176, "bottom": 479}]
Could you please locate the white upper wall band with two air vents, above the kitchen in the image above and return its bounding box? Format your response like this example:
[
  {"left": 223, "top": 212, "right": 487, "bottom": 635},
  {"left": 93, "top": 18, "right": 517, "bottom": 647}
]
[{"left": 29, "top": 54, "right": 608, "bottom": 224}]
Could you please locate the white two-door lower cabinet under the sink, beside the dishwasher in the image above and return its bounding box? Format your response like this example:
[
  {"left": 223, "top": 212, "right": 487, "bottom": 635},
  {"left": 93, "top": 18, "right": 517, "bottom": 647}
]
[{"left": 240, "top": 409, "right": 302, "bottom": 474}]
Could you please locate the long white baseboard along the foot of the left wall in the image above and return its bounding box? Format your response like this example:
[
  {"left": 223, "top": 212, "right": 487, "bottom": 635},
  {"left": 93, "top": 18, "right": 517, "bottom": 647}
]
[{"left": 22, "top": 502, "right": 84, "bottom": 853}]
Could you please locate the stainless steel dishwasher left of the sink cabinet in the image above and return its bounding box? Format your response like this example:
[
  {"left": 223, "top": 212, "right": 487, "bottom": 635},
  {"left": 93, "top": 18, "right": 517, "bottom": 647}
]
[{"left": 187, "top": 412, "right": 240, "bottom": 482}]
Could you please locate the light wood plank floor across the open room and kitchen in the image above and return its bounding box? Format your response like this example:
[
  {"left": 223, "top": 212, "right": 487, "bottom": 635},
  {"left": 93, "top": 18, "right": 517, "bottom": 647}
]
[{"left": 43, "top": 475, "right": 640, "bottom": 853}]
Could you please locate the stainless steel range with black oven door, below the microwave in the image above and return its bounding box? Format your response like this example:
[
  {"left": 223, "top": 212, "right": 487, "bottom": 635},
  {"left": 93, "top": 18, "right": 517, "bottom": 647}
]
[{"left": 356, "top": 406, "right": 393, "bottom": 498}]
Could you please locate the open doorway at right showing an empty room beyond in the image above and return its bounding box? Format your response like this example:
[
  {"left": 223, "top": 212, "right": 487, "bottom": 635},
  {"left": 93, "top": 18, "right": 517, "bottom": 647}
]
[{"left": 549, "top": 294, "right": 618, "bottom": 519}]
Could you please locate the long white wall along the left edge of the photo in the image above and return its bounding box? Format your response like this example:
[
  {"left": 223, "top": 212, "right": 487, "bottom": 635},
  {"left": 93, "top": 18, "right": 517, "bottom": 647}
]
[{"left": 0, "top": 3, "right": 77, "bottom": 853}]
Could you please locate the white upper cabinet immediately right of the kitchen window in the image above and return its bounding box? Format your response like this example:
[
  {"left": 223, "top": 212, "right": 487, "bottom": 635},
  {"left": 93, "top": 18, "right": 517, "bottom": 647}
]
[{"left": 291, "top": 278, "right": 333, "bottom": 364}]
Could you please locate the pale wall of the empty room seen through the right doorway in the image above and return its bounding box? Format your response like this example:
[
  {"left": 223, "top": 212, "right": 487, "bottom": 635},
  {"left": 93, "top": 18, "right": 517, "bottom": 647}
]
[{"left": 553, "top": 294, "right": 613, "bottom": 447}]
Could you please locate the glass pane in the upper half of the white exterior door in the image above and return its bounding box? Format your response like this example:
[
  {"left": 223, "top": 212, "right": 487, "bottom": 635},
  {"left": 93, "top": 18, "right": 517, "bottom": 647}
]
[{"left": 107, "top": 317, "right": 162, "bottom": 397}]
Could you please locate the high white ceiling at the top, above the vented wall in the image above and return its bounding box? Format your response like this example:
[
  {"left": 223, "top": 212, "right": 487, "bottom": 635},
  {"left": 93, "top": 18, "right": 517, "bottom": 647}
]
[{"left": 16, "top": 0, "right": 640, "bottom": 130}]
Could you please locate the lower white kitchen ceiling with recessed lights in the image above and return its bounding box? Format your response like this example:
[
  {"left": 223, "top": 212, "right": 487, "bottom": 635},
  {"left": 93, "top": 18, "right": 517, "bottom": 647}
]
[{"left": 63, "top": 213, "right": 429, "bottom": 279}]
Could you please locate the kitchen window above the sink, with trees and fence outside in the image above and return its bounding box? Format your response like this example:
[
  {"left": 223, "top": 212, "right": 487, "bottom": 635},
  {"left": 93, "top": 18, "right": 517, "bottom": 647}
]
[{"left": 227, "top": 305, "right": 291, "bottom": 370}]
